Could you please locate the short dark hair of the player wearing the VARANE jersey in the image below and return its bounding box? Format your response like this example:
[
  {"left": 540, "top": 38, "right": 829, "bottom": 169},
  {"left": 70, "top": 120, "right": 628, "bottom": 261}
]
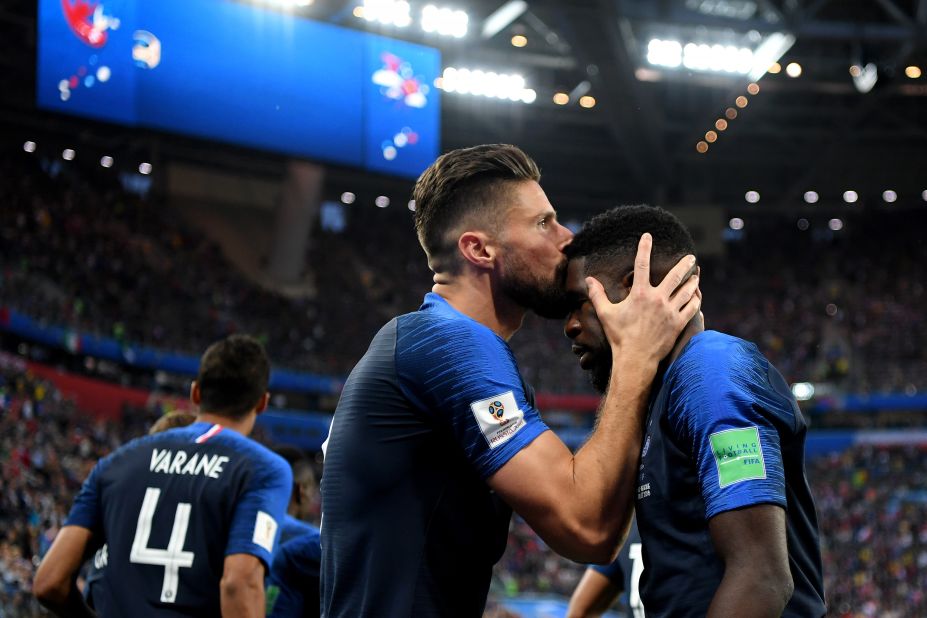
[{"left": 196, "top": 335, "right": 270, "bottom": 418}]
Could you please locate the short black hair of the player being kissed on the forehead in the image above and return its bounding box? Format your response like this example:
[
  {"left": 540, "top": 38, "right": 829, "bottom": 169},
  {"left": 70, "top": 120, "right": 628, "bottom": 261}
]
[{"left": 564, "top": 204, "right": 695, "bottom": 285}]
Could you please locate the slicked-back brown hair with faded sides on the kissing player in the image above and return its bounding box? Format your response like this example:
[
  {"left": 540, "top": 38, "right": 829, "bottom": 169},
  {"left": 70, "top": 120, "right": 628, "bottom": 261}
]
[{"left": 412, "top": 144, "right": 541, "bottom": 272}]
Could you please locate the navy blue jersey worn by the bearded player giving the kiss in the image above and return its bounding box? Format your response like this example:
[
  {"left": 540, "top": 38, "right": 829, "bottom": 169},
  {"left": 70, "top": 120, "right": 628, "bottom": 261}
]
[{"left": 322, "top": 294, "right": 547, "bottom": 618}]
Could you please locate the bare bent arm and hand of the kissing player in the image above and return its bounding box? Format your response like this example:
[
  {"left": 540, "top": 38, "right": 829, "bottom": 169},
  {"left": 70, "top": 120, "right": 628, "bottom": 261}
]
[{"left": 488, "top": 234, "right": 699, "bottom": 563}]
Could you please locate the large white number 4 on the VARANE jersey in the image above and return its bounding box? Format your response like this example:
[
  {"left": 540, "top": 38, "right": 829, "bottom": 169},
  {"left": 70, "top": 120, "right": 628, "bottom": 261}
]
[{"left": 129, "top": 487, "right": 193, "bottom": 603}]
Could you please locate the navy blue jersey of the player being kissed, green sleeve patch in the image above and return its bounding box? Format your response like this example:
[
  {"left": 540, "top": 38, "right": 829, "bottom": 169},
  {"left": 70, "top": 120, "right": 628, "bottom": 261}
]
[{"left": 636, "top": 331, "right": 826, "bottom": 618}]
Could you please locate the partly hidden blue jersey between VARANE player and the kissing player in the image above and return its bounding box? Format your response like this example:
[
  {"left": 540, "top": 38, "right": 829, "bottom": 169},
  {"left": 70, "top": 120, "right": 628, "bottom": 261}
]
[{"left": 267, "top": 524, "right": 322, "bottom": 618}]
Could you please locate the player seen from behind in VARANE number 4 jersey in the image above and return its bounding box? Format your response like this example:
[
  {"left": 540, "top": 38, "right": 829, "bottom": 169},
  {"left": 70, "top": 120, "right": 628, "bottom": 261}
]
[{"left": 33, "top": 335, "right": 292, "bottom": 618}]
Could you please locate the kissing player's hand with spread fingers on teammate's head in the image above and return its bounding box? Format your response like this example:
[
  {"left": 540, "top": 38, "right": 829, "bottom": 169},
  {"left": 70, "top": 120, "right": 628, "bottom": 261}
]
[{"left": 586, "top": 234, "right": 702, "bottom": 363}]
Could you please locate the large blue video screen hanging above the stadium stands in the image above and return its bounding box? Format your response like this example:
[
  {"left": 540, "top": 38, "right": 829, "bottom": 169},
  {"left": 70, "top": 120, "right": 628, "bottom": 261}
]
[{"left": 36, "top": 0, "right": 441, "bottom": 177}]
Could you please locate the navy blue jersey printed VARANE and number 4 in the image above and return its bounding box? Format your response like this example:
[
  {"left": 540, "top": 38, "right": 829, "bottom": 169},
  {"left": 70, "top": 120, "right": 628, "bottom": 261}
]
[{"left": 65, "top": 423, "right": 293, "bottom": 617}]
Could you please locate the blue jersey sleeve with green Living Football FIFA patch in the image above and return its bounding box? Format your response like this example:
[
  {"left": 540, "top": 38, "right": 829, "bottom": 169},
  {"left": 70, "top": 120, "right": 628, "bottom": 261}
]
[{"left": 668, "top": 349, "right": 786, "bottom": 520}]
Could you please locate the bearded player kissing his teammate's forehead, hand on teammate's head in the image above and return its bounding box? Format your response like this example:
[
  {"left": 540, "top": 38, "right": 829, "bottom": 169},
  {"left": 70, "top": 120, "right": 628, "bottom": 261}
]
[{"left": 321, "top": 145, "right": 699, "bottom": 618}]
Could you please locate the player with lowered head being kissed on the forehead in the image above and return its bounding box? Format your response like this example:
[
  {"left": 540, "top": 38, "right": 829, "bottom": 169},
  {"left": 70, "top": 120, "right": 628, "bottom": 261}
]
[{"left": 565, "top": 206, "right": 826, "bottom": 618}]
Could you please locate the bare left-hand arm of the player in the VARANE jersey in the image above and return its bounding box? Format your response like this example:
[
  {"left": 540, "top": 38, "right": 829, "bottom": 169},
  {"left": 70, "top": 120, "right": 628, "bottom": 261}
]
[{"left": 32, "top": 526, "right": 96, "bottom": 616}]
